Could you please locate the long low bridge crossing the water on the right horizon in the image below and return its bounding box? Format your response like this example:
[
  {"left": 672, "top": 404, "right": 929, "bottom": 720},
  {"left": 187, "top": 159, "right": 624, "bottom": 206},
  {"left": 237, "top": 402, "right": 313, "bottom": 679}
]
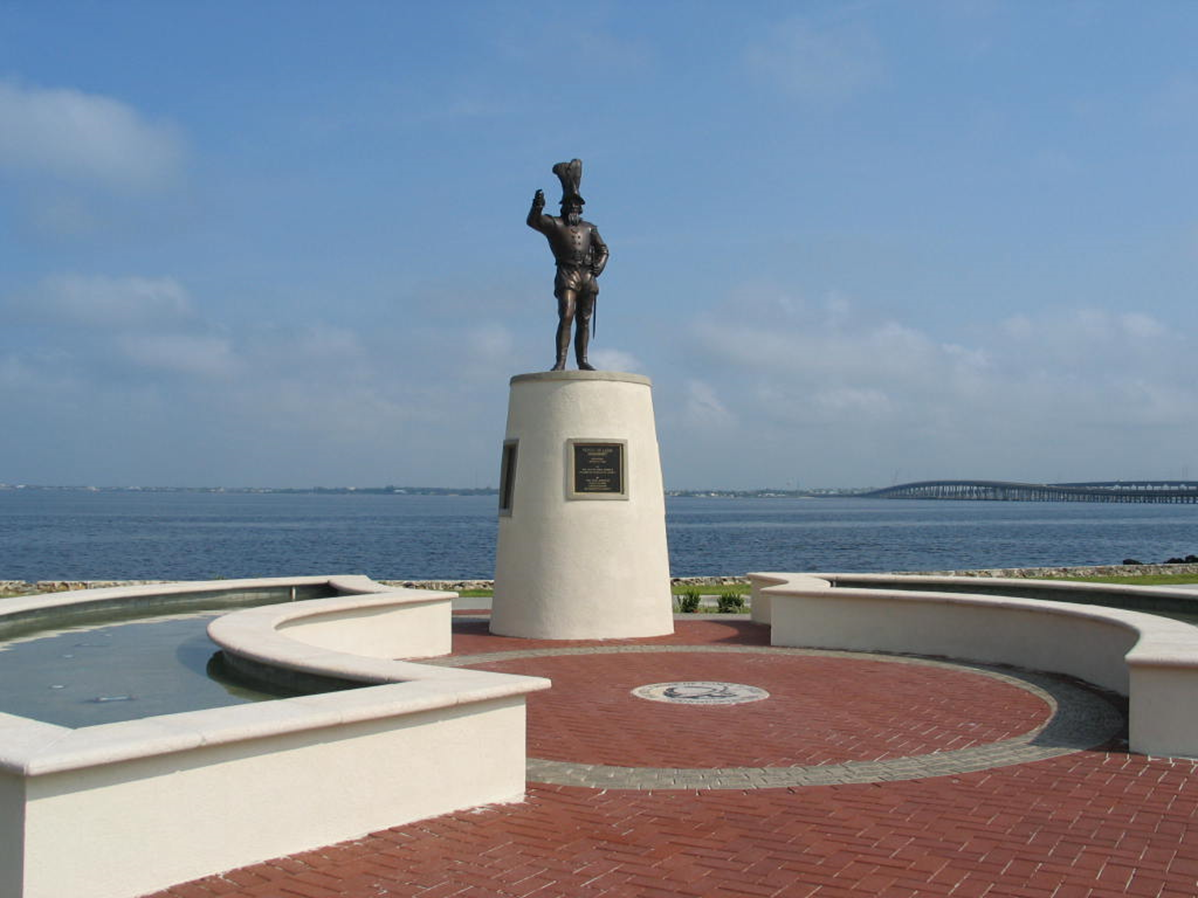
[{"left": 858, "top": 480, "right": 1198, "bottom": 504}]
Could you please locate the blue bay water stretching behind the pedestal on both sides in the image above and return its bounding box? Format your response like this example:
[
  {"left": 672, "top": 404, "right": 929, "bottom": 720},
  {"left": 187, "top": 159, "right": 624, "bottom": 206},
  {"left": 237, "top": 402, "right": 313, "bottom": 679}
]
[{"left": 0, "top": 490, "right": 1198, "bottom": 581}]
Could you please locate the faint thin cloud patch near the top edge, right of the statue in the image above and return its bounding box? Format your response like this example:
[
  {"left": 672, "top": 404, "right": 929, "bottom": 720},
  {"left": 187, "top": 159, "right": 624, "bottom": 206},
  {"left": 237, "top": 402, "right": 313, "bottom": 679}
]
[{"left": 746, "top": 18, "right": 883, "bottom": 103}]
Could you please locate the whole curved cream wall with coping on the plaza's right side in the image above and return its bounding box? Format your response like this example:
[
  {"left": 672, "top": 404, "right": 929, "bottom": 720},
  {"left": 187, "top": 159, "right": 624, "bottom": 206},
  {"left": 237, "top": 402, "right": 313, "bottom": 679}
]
[{"left": 749, "top": 572, "right": 1198, "bottom": 758}]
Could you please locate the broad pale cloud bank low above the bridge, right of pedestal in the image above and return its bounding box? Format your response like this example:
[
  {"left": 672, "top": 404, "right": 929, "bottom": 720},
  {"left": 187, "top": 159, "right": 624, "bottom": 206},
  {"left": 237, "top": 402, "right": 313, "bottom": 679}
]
[{"left": 662, "top": 290, "right": 1198, "bottom": 486}]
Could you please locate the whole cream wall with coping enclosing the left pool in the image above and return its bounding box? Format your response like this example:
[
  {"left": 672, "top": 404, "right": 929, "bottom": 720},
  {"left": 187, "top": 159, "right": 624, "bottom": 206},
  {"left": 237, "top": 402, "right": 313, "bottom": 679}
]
[{"left": 0, "top": 577, "right": 550, "bottom": 898}]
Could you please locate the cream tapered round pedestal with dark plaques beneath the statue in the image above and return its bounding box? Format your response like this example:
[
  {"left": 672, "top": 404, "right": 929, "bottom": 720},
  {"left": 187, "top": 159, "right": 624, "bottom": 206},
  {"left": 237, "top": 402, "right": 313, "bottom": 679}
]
[{"left": 491, "top": 371, "right": 673, "bottom": 639}]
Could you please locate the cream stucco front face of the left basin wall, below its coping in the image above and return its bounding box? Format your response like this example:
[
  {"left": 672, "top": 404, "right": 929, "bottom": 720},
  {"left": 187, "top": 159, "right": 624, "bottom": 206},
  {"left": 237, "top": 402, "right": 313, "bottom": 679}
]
[{"left": 18, "top": 704, "right": 525, "bottom": 898}]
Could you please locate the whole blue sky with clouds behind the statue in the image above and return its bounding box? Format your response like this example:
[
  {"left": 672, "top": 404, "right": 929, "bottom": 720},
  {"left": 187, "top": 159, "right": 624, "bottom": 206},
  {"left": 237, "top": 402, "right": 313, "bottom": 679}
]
[{"left": 0, "top": 0, "right": 1198, "bottom": 489}]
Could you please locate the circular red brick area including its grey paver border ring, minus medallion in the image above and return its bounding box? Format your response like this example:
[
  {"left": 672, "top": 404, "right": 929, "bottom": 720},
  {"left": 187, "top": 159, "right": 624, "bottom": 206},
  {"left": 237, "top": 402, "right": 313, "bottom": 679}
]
[{"left": 441, "top": 645, "right": 1123, "bottom": 789}]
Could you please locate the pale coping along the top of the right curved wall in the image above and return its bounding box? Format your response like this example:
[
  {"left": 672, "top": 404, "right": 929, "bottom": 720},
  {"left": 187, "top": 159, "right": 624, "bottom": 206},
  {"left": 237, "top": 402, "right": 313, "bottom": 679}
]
[{"left": 749, "top": 571, "right": 1198, "bottom": 671}]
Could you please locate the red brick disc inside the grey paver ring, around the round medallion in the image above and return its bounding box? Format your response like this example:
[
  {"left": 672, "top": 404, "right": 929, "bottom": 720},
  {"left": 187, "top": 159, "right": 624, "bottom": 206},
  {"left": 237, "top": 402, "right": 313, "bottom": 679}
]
[{"left": 472, "top": 651, "right": 1053, "bottom": 767}]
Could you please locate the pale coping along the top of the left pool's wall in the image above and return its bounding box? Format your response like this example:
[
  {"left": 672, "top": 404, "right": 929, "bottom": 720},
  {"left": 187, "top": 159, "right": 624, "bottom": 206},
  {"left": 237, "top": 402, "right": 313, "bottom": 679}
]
[{"left": 0, "top": 576, "right": 550, "bottom": 777}]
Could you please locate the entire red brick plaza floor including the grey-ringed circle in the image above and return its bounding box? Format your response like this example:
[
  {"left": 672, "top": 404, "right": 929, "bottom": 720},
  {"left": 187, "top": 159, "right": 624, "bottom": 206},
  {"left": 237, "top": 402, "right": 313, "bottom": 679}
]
[{"left": 149, "top": 617, "right": 1198, "bottom": 898}]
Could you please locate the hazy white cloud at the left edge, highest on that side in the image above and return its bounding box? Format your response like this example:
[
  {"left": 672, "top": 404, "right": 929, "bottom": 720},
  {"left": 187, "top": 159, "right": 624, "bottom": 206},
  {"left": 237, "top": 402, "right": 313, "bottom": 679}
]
[{"left": 0, "top": 80, "right": 183, "bottom": 190}]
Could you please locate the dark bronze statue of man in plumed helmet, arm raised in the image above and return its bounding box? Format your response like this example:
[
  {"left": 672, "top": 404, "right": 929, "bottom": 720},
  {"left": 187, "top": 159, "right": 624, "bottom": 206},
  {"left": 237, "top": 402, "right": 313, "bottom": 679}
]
[{"left": 528, "top": 159, "right": 607, "bottom": 371}]
